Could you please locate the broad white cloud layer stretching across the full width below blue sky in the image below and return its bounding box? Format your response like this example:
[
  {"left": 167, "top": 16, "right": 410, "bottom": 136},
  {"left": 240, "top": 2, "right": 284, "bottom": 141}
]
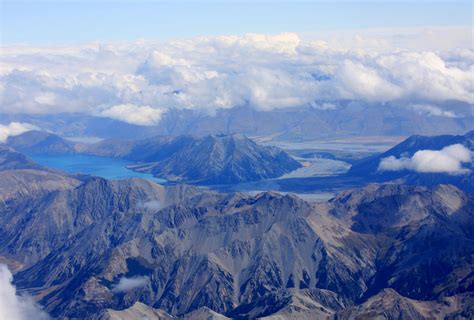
[{"left": 0, "top": 28, "right": 474, "bottom": 126}]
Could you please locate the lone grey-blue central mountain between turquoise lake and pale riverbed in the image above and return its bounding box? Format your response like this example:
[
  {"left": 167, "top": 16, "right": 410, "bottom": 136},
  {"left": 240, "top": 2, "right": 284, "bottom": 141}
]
[{"left": 127, "top": 135, "right": 301, "bottom": 184}]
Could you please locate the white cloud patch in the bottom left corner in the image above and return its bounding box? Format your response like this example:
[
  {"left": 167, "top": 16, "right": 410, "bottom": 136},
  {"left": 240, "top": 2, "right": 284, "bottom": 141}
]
[{"left": 0, "top": 264, "right": 49, "bottom": 320}]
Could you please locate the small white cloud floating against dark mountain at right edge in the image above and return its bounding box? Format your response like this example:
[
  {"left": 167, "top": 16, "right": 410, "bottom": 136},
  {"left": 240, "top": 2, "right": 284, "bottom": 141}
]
[{"left": 378, "top": 144, "right": 472, "bottom": 174}]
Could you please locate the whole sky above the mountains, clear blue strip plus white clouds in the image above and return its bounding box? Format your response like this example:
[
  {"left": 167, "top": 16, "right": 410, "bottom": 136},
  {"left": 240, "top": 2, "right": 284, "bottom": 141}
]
[{"left": 0, "top": 0, "right": 474, "bottom": 132}]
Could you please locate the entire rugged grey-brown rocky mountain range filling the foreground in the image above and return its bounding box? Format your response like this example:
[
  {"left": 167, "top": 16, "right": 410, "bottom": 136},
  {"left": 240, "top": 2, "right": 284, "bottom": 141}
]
[{"left": 0, "top": 156, "right": 474, "bottom": 319}]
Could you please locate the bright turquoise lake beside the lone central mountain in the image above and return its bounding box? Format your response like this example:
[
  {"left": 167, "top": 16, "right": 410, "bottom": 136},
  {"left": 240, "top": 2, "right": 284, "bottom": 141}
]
[{"left": 31, "top": 155, "right": 166, "bottom": 183}]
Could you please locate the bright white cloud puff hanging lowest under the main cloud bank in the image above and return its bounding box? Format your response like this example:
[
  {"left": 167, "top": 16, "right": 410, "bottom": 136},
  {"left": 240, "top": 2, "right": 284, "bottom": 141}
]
[{"left": 98, "top": 104, "right": 163, "bottom": 126}]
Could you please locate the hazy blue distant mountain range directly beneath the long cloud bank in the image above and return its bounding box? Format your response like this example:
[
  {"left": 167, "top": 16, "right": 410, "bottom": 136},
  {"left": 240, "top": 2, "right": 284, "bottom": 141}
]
[{"left": 0, "top": 101, "right": 474, "bottom": 140}]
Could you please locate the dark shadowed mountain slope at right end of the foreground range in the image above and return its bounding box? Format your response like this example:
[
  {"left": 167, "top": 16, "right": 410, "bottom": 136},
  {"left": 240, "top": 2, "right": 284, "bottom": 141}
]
[{"left": 331, "top": 184, "right": 474, "bottom": 300}]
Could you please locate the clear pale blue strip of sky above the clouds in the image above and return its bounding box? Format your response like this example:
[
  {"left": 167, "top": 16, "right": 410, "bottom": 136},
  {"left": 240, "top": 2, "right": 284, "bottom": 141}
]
[{"left": 0, "top": 0, "right": 473, "bottom": 45}]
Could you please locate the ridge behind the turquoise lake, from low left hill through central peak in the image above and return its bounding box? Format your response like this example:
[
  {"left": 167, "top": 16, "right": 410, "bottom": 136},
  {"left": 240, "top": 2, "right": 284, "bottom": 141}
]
[{"left": 7, "top": 131, "right": 301, "bottom": 184}]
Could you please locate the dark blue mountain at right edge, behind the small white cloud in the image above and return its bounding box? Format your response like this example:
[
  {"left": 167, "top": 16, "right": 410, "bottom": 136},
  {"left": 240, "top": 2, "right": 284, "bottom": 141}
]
[{"left": 347, "top": 131, "right": 474, "bottom": 192}]
